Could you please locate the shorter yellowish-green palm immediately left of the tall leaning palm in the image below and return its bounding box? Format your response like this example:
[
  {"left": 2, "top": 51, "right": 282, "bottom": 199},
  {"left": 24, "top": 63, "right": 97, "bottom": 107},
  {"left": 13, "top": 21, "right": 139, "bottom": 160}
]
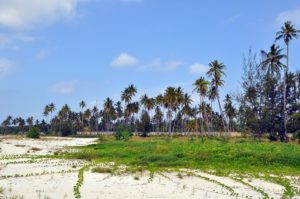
[{"left": 194, "top": 77, "right": 209, "bottom": 132}]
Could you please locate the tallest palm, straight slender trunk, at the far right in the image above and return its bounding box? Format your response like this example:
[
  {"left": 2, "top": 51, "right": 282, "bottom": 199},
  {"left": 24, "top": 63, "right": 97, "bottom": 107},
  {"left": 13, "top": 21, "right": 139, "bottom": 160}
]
[{"left": 276, "top": 21, "right": 300, "bottom": 139}]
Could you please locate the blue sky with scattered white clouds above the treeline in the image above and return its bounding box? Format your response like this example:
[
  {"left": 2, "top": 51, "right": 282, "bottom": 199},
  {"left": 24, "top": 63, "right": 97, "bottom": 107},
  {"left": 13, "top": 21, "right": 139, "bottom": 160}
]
[{"left": 0, "top": 0, "right": 300, "bottom": 120}]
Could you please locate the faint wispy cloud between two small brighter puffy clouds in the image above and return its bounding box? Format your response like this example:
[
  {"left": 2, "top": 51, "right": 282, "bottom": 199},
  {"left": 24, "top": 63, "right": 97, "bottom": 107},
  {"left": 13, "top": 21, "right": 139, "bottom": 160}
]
[{"left": 139, "top": 58, "right": 183, "bottom": 72}]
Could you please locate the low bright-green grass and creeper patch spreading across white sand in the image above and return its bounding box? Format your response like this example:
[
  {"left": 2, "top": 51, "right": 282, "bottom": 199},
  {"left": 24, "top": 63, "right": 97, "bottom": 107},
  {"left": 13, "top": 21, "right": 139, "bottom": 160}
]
[{"left": 65, "top": 137, "right": 300, "bottom": 175}]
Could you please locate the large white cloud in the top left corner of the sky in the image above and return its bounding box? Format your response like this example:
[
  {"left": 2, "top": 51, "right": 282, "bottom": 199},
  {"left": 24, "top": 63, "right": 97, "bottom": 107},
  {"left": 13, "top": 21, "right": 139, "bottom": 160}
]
[{"left": 0, "top": 0, "right": 80, "bottom": 29}]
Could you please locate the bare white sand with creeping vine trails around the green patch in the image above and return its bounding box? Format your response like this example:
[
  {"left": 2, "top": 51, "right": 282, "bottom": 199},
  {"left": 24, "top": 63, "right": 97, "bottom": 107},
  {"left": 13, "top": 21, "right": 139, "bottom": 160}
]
[{"left": 0, "top": 137, "right": 300, "bottom": 199}]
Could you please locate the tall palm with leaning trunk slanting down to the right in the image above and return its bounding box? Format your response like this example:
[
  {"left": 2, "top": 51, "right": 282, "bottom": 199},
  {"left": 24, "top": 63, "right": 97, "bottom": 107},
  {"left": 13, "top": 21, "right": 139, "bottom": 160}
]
[{"left": 207, "top": 60, "right": 228, "bottom": 133}]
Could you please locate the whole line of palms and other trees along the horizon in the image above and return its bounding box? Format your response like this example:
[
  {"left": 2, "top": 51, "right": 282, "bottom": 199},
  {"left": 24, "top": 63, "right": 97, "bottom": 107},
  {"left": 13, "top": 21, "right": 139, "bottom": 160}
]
[{"left": 0, "top": 22, "right": 300, "bottom": 141}]
